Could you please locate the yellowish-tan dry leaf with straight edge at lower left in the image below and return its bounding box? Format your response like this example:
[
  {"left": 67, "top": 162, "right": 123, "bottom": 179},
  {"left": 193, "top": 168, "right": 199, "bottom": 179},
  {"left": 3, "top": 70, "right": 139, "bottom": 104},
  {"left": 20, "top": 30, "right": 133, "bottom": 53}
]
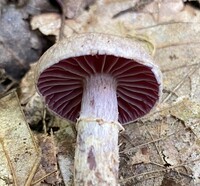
[{"left": 0, "top": 92, "right": 40, "bottom": 186}]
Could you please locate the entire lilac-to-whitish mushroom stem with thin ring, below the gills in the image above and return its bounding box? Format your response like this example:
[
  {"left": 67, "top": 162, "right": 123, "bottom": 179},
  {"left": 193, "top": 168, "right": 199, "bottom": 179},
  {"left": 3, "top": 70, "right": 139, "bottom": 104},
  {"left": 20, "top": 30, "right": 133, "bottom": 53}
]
[{"left": 75, "top": 74, "right": 119, "bottom": 186}]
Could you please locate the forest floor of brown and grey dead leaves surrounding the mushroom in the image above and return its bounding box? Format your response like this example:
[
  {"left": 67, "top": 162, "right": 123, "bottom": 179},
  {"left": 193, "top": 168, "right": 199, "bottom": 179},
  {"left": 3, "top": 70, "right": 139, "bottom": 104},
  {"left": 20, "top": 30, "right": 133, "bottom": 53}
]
[{"left": 0, "top": 0, "right": 200, "bottom": 186}]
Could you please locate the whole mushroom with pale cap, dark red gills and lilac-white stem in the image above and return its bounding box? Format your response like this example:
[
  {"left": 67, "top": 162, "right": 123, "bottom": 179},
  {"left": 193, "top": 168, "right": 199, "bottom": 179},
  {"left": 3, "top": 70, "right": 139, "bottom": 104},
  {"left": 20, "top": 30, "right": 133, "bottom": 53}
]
[{"left": 36, "top": 33, "right": 161, "bottom": 186}]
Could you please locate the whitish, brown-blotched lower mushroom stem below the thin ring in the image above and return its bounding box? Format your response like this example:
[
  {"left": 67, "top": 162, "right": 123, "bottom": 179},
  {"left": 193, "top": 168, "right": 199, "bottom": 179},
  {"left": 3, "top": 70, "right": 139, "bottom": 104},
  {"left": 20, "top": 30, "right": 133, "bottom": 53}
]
[{"left": 75, "top": 120, "right": 119, "bottom": 186}]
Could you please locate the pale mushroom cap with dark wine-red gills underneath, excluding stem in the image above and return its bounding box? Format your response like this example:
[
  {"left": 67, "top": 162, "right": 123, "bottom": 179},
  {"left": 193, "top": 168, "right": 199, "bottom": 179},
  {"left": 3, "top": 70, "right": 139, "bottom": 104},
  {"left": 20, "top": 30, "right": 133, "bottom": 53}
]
[{"left": 35, "top": 33, "right": 162, "bottom": 124}]
